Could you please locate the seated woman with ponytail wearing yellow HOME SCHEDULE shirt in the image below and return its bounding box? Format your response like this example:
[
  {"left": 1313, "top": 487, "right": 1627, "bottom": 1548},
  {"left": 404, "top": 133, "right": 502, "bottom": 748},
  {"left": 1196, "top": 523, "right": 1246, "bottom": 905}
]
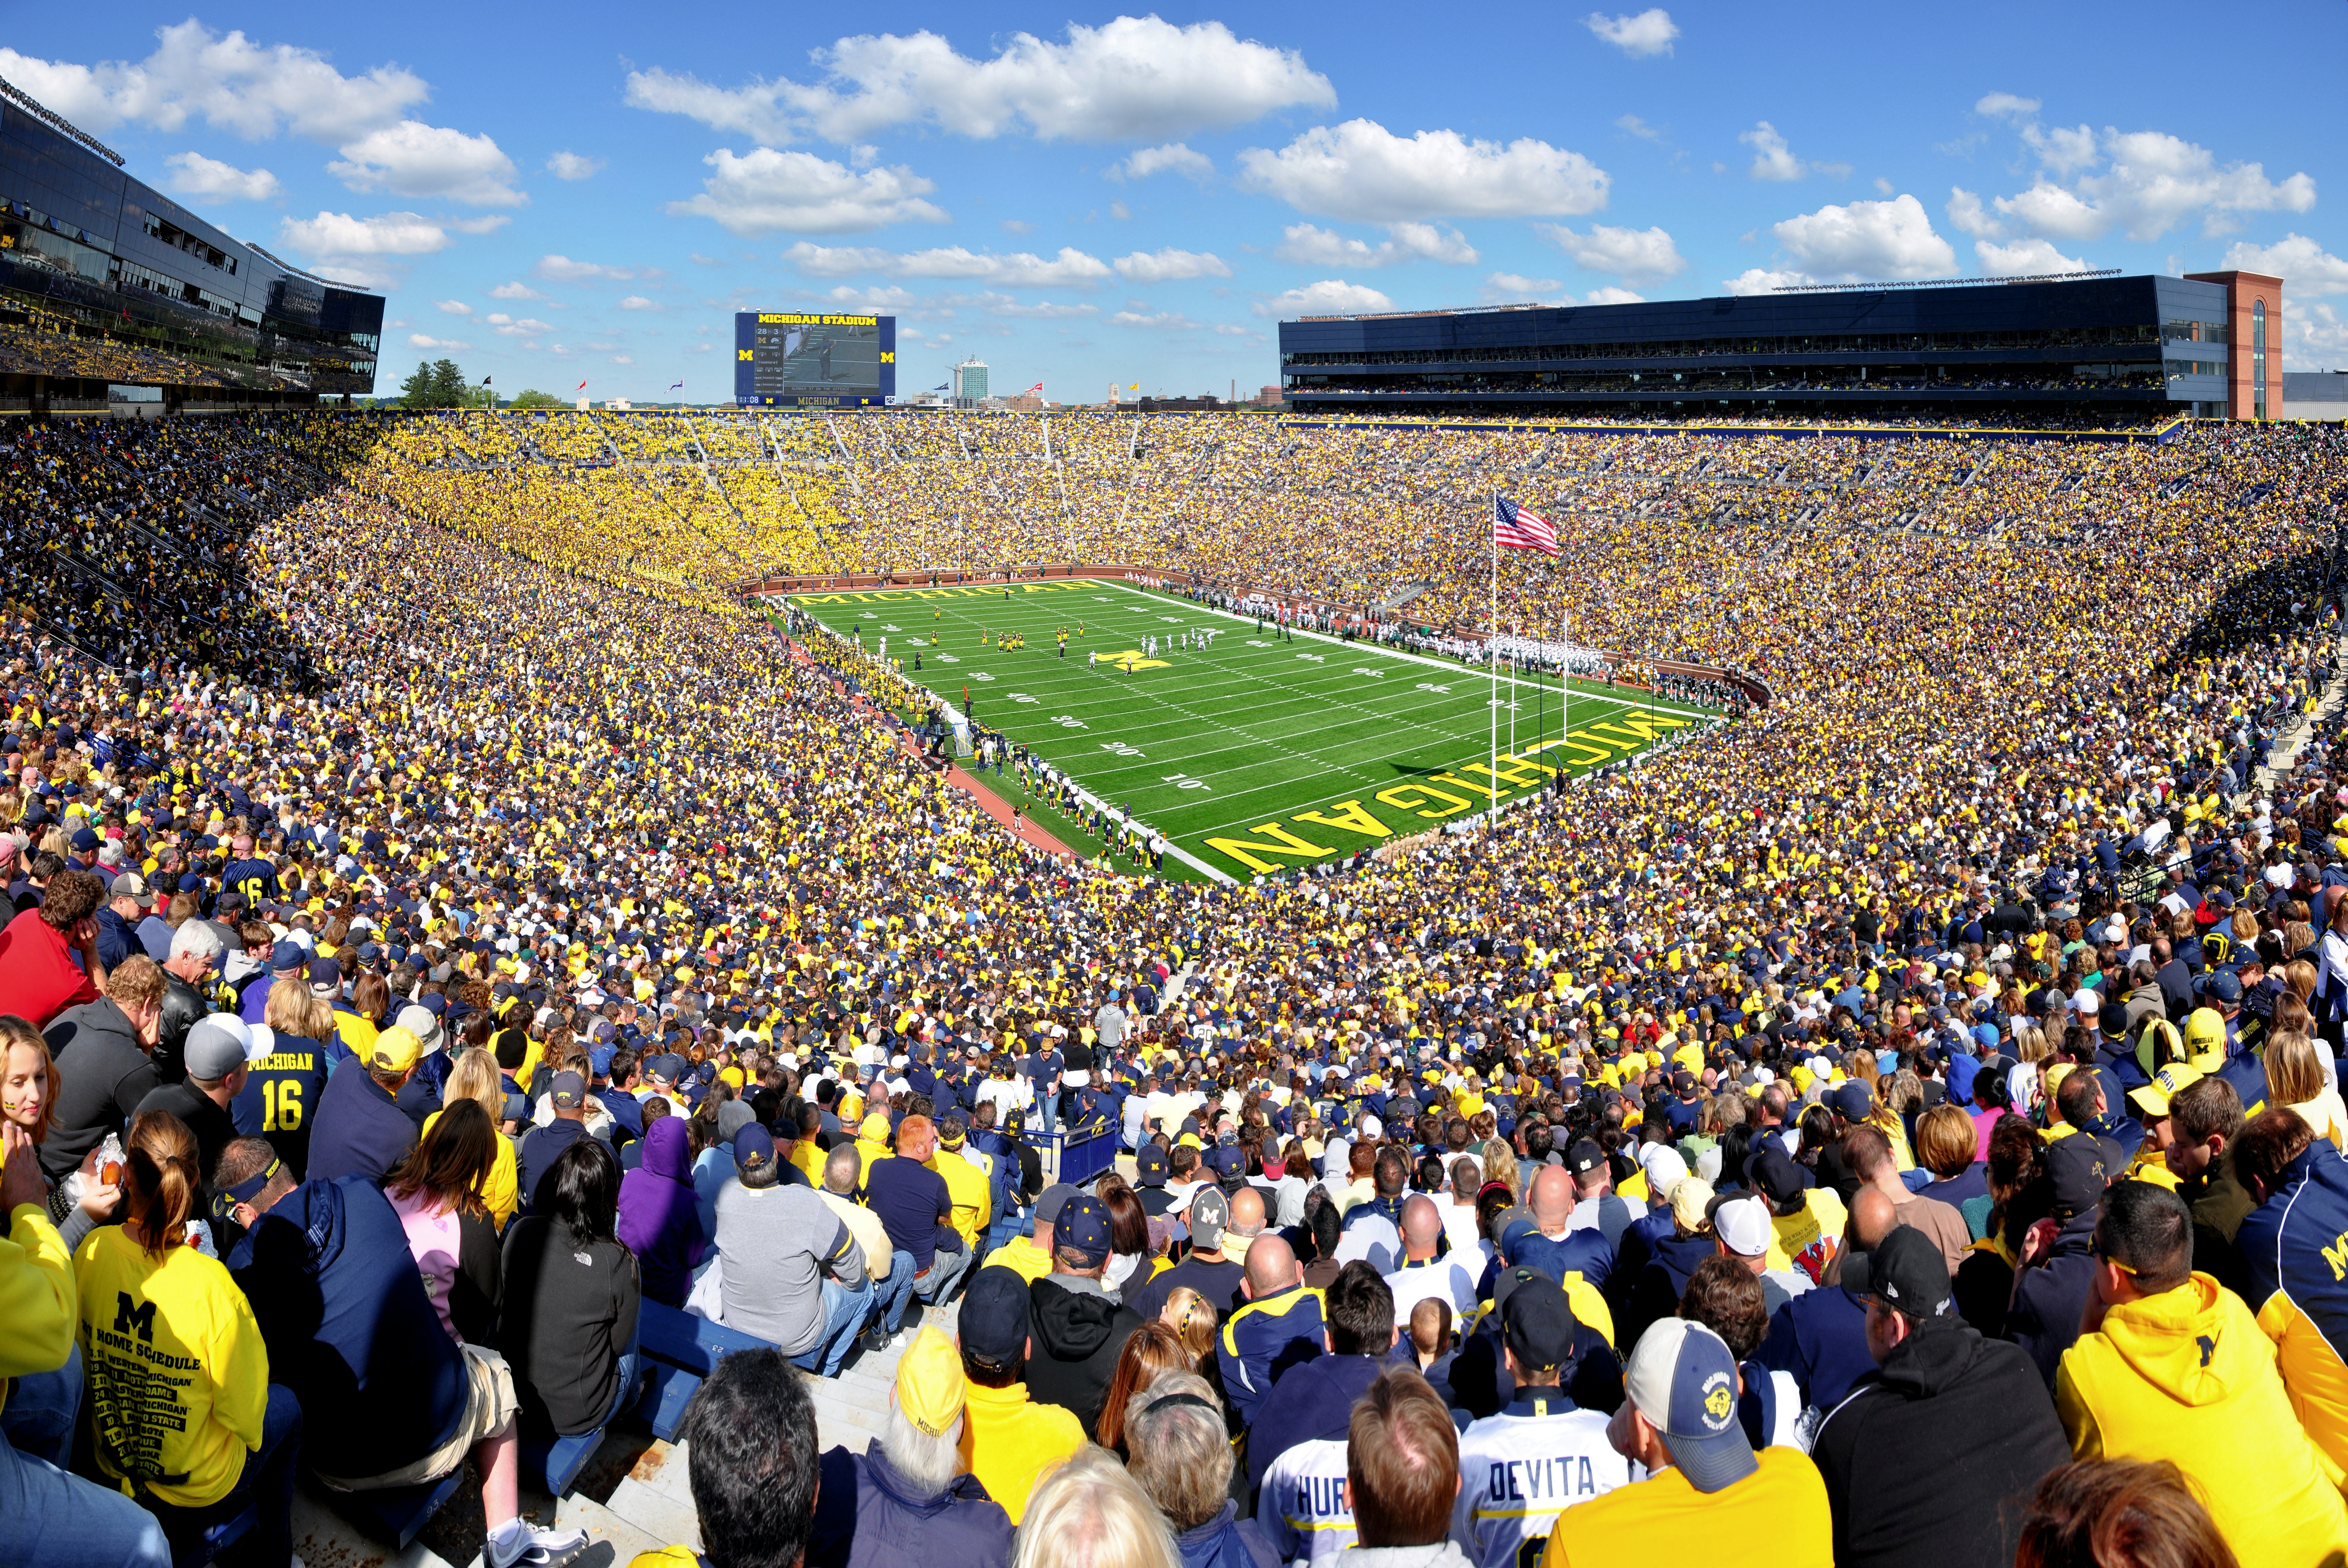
[{"left": 73, "top": 1110, "right": 301, "bottom": 1566}]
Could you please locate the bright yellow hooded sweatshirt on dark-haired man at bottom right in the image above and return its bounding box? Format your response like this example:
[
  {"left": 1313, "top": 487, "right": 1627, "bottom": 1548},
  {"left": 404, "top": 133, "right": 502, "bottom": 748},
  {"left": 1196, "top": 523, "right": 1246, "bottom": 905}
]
[{"left": 2055, "top": 1275, "right": 2348, "bottom": 1568}]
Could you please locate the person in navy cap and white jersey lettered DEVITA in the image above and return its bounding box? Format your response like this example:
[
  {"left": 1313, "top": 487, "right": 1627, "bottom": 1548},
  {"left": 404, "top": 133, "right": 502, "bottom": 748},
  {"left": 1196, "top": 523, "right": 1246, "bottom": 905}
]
[{"left": 1451, "top": 1279, "right": 1646, "bottom": 1568}]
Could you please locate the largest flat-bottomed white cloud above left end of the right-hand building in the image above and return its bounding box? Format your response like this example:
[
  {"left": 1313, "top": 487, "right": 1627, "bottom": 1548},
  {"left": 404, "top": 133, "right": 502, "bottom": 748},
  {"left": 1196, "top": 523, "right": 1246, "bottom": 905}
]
[{"left": 1240, "top": 120, "right": 1608, "bottom": 223}]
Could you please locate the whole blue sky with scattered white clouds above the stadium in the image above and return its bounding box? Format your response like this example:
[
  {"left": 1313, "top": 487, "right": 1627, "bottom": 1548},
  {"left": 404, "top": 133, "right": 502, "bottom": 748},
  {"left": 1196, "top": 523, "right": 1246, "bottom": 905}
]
[{"left": 0, "top": 0, "right": 2348, "bottom": 401}]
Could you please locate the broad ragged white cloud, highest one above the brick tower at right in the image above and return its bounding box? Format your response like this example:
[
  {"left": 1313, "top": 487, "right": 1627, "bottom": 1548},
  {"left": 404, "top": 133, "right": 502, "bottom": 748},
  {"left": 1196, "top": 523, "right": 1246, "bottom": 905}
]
[{"left": 1996, "top": 124, "right": 2315, "bottom": 242}]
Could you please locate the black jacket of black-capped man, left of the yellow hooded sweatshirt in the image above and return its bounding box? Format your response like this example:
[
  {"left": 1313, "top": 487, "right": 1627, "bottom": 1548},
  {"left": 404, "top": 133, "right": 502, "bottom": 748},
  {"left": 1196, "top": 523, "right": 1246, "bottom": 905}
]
[{"left": 1810, "top": 1317, "right": 2071, "bottom": 1568}]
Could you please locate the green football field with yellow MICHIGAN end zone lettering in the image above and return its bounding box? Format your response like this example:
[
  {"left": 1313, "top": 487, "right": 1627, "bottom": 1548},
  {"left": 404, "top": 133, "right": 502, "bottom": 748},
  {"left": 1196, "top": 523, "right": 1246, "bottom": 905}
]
[{"left": 791, "top": 580, "right": 1719, "bottom": 880}]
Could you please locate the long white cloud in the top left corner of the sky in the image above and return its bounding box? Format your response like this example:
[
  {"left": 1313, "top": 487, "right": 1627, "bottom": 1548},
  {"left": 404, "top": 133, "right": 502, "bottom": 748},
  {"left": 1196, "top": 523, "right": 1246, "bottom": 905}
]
[{"left": 0, "top": 21, "right": 430, "bottom": 143}]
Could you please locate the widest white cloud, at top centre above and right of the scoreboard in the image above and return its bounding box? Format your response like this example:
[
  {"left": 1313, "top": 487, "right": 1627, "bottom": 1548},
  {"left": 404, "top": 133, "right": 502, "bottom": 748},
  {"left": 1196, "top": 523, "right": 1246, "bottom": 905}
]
[{"left": 627, "top": 16, "right": 1336, "bottom": 146}]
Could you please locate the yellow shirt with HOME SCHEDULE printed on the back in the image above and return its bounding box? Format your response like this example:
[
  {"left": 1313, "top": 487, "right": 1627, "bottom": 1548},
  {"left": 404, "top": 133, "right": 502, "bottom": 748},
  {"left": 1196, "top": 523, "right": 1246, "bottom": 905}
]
[{"left": 73, "top": 1225, "right": 270, "bottom": 1507}]
